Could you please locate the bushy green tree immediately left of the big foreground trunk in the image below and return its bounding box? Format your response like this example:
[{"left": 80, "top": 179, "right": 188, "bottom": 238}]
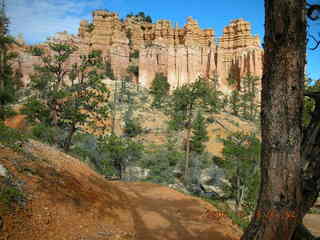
[{"left": 219, "top": 132, "right": 261, "bottom": 212}]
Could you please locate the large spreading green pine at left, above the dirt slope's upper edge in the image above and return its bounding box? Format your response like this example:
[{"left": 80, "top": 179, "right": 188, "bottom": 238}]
[{"left": 23, "top": 43, "right": 109, "bottom": 151}]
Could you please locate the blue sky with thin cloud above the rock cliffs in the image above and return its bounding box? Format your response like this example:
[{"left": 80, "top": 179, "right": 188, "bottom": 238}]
[{"left": 7, "top": 0, "right": 320, "bottom": 79}]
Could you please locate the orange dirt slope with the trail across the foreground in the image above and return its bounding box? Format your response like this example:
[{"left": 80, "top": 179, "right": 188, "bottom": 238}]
[{"left": 0, "top": 141, "right": 241, "bottom": 240}]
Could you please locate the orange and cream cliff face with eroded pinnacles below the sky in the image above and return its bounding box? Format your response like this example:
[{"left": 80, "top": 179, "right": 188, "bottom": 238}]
[{"left": 15, "top": 11, "right": 263, "bottom": 93}]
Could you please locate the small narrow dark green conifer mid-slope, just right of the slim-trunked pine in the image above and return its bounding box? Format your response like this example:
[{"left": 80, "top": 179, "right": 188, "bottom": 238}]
[{"left": 190, "top": 111, "right": 209, "bottom": 154}]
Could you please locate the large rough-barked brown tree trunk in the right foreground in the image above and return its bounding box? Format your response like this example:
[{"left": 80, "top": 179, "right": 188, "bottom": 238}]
[{"left": 241, "top": 0, "right": 306, "bottom": 240}]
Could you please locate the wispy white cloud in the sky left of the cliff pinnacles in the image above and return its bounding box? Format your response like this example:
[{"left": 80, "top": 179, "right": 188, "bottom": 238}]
[{"left": 7, "top": 0, "right": 104, "bottom": 43}]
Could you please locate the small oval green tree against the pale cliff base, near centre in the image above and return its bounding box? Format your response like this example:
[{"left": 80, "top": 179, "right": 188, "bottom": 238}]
[{"left": 150, "top": 73, "right": 170, "bottom": 108}]
